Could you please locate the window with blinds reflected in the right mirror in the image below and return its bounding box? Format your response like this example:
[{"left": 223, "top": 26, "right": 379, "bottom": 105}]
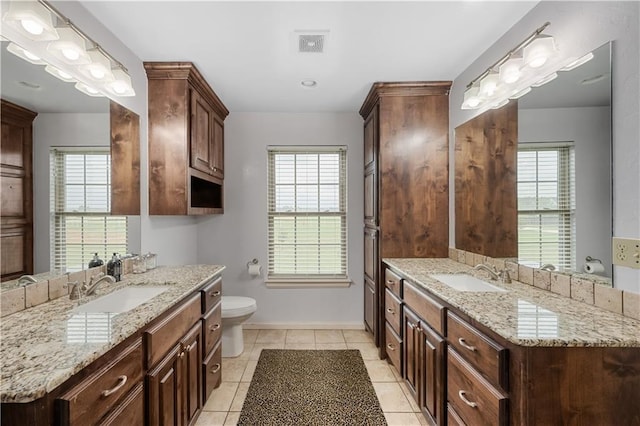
[{"left": 518, "top": 144, "right": 575, "bottom": 270}]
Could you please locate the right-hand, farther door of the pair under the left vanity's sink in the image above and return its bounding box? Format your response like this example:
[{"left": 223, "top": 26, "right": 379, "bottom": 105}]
[{"left": 180, "top": 322, "right": 202, "bottom": 425}]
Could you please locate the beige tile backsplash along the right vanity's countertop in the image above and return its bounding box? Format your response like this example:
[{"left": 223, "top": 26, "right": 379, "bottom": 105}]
[{"left": 449, "top": 248, "right": 640, "bottom": 319}]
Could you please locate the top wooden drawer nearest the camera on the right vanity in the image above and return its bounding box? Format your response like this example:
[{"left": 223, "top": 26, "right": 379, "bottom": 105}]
[{"left": 447, "top": 312, "right": 509, "bottom": 390}]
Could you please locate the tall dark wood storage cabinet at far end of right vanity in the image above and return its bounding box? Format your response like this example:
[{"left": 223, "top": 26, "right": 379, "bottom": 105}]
[{"left": 360, "top": 81, "right": 451, "bottom": 356}]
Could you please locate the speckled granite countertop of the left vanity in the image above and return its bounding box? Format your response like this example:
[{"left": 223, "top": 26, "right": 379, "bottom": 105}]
[{"left": 0, "top": 265, "right": 224, "bottom": 402}]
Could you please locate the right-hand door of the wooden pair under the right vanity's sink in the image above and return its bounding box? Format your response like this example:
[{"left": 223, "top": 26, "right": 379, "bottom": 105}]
[{"left": 419, "top": 322, "right": 445, "bottom": 425}]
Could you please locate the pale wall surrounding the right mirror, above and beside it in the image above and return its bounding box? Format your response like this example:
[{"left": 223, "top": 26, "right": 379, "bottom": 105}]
[{"left": 449, "top": 1, "right": 640, "bottom": 293}]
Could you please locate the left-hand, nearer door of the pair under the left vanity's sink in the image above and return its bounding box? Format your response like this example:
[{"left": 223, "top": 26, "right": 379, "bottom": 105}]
[{"left": 147, "top": 345, "right": 183, "bottom": 426}]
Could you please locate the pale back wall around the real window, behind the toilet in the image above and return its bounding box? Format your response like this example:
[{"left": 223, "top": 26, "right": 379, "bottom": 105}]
[{"left": 198, "top": 112, "right": 364, "bottom": 327}]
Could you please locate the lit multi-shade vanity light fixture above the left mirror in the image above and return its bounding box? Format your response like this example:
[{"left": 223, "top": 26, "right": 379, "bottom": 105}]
[{"left": 0, "top": 0, "right": 135, "bottom": 100}]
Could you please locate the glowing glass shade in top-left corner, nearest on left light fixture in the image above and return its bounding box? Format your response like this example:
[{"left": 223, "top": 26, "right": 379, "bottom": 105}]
[{"left": 2, "top": 0, "right": 58, "bottom": 41}]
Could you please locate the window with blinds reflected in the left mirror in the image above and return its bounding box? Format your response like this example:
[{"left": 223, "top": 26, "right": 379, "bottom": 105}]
[{"left": 51, "top": 147, "right": 127, "bottom": 271}]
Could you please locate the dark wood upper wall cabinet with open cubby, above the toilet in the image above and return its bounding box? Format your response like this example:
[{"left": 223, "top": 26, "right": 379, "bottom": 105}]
[{"left": 144, "top": 62, "right": 229, "bottom": 215}]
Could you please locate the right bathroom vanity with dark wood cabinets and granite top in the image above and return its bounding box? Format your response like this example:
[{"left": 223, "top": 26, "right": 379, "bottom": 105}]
[{"left": 384, "top": 259, "right": 640, "bottom": 425}]
